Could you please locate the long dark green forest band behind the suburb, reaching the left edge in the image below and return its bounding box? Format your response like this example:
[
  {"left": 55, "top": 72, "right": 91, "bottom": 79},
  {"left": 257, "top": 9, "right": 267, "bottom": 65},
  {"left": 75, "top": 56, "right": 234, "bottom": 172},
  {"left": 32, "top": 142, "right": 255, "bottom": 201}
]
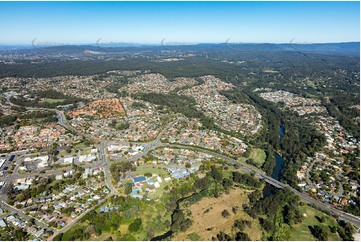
[{"left": 0, "top": 57, "right": 233, "bottom": 78}]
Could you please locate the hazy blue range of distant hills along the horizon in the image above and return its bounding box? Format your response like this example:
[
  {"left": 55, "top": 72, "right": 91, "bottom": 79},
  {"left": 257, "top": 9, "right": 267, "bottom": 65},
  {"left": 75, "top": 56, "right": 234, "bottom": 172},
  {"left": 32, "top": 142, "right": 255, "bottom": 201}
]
[{"left": 0, "top": 42, "right": 360, "bottom": 56}]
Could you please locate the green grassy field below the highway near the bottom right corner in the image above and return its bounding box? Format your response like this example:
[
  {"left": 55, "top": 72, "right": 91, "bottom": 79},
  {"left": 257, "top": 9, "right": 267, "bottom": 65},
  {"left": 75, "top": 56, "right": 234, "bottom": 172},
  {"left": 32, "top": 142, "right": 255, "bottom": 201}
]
[{"left": 290, "top": 206, "right": 341, "bottom": 241}]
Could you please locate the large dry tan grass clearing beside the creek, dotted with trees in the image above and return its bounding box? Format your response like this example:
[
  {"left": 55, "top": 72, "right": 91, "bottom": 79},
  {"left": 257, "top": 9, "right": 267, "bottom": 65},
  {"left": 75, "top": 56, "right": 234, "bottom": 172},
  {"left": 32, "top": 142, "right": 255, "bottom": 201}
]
[{"left": 173, "top": 188, "right": 262, "bottom": 241}]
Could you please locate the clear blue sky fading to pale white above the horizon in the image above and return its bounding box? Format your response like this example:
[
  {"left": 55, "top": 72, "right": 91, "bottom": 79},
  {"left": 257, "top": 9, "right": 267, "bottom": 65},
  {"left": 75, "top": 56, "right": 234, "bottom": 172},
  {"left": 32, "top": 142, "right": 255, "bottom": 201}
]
[{"left": 0, "top": 2, "right": 360, "bottom": 46}]
